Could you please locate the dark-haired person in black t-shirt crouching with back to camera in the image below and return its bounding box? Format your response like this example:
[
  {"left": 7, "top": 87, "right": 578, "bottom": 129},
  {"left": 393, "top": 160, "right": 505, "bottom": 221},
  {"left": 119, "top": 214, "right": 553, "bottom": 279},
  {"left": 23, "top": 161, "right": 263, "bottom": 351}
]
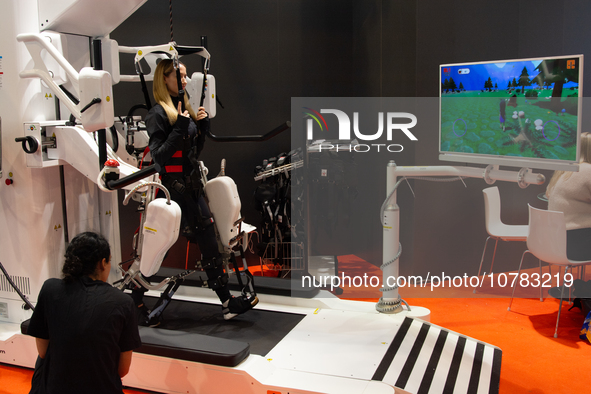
[{"left": 27, "top": 232, "right": 141, "bottom": 394}]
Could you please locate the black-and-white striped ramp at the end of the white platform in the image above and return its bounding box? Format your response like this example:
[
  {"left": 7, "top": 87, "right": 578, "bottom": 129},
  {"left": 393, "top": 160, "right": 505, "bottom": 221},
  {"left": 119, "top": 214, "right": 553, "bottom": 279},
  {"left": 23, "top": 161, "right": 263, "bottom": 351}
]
[{"left": 372, "top": 318, "right": 502, "bottom": 394}]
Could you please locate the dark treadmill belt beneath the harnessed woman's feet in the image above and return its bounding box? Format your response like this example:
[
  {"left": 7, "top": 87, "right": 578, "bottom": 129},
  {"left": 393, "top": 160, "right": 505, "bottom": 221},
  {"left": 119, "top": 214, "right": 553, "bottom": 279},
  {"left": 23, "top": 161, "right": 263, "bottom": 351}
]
[{"left": 144, "top": 296, "right": 305, "bottom": 356}]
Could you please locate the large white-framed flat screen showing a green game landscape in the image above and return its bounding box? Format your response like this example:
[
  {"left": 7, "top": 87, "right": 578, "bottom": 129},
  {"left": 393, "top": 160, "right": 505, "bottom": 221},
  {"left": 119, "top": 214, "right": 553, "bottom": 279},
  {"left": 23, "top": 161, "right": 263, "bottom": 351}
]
[{"left": 439, "top": 55, "right": 583, "bottom": 171}]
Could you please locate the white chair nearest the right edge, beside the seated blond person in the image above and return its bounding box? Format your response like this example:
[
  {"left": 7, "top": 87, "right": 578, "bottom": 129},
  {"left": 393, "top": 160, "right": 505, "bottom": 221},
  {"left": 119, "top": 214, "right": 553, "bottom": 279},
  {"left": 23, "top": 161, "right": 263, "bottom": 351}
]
[{"left": 507, "top": 205, "right": 591, "bottom": 338}]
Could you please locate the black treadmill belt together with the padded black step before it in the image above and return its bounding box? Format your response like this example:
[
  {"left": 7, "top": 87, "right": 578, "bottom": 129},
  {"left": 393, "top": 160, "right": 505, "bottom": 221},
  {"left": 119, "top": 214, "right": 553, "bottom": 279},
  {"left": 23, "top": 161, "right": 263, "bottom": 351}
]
[{"left": 21, "top": 296, "right": 305, "bottom": 367}]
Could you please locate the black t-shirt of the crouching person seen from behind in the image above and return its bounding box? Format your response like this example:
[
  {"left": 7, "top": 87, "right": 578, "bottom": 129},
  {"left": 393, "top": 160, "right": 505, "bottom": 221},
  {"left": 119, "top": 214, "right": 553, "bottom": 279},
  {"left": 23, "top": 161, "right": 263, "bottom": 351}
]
[{"left": 27, "top": 276, "right": 141, "bottom": 394}]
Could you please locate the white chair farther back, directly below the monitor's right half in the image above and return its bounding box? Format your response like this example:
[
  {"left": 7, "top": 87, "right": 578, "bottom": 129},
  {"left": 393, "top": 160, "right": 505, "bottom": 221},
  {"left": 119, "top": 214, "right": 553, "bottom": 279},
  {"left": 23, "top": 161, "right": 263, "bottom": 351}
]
[{"left": 474, "top": 186, "right": 528, "bottom": 286}]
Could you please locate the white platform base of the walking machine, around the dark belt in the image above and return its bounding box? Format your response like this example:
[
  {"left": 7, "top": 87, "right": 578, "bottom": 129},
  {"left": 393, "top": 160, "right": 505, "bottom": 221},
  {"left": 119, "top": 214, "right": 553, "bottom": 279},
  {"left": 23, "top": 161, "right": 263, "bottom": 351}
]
[{"left": 0, "top": 287, "right": 501, "bottom": 394}]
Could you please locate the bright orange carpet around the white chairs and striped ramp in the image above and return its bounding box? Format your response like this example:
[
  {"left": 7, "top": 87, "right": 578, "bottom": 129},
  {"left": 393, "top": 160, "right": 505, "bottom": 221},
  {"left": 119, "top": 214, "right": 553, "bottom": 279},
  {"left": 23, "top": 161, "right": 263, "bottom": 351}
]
[{"left": 339, "top": 256, "right": 591, "bottom": 394}]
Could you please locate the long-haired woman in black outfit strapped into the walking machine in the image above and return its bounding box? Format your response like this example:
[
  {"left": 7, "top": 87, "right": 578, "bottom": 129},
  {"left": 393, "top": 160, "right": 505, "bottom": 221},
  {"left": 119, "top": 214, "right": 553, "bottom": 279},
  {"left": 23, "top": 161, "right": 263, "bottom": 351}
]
[{"left": 145, "top": 59, "right": 258, "bottom": 318}]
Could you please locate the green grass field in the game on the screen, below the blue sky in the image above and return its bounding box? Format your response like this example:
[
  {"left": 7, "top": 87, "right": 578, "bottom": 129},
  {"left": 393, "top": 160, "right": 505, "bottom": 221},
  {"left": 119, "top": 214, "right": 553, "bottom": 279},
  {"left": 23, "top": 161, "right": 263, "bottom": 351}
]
[{"left": 441, "top": 88, "right": 578, "bottom": 161}]
